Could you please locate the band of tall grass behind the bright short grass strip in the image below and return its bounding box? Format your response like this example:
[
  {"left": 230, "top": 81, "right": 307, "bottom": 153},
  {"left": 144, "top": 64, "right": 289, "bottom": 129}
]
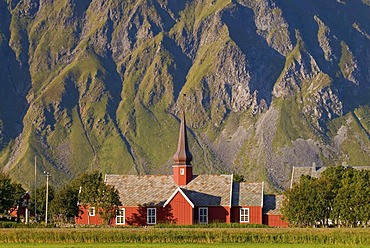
[{"left": 0, "top": 228, "right": 370, "bottom": 246}]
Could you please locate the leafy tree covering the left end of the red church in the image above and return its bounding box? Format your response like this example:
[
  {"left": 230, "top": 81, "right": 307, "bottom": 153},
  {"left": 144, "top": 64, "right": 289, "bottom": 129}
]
[{"left": 78, "top": 172, "right": 121, "bottom": 224}]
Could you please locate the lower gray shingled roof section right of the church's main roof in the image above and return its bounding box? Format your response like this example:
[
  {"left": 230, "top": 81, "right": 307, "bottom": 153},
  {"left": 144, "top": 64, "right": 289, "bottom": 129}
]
[{"left": 232, "top": 182, "right": 263, "bottom": 206}]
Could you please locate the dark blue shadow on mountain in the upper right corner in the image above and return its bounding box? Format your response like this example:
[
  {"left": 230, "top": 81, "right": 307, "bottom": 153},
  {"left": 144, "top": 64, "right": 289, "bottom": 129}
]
[{"left": 276, "top": 0, "right": 370, "bottom": 114}]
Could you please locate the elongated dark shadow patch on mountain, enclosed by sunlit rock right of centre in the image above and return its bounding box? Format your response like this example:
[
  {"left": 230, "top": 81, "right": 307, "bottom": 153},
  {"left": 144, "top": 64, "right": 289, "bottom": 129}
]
[{"left": 222, "top": 4, "right": 285, "bottom": 106}]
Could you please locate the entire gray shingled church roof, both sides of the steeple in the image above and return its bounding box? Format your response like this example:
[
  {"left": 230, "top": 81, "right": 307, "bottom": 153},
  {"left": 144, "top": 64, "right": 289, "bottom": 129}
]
[{"left": 105, "top": 175, "right": 263, "bottom": 206}]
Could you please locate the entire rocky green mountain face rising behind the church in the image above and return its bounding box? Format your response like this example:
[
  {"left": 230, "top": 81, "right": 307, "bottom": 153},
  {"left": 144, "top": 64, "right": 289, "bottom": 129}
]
[{"left": 0, "top": 0, "right": 370, "bottom": 190}]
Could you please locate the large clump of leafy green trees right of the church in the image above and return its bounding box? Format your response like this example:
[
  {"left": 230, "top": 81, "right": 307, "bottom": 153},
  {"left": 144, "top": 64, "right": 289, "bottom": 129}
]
[{"left": 282, "top": 166, "right": 370, "bottom": 227}]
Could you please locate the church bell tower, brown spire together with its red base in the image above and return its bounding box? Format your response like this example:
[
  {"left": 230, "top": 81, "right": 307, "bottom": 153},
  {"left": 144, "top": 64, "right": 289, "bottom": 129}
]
[{"left": 172, "top": 111, "right": 193, "bottom": 186}]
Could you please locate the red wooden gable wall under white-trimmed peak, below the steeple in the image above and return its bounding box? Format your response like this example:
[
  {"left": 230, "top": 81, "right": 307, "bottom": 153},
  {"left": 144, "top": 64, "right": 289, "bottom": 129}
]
[{"left": 169, "top": 192, "right": 193, "bottom": 225}]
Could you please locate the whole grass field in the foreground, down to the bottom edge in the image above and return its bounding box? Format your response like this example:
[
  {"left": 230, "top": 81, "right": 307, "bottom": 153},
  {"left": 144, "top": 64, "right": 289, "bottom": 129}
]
[{"left": 0, "top": 228, "right": 370, "bottom": 248}]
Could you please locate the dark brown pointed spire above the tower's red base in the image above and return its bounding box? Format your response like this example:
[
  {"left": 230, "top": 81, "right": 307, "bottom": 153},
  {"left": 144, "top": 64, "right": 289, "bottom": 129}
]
[{"left": 173, "top": 111, "right": 193, "bottom": 166}]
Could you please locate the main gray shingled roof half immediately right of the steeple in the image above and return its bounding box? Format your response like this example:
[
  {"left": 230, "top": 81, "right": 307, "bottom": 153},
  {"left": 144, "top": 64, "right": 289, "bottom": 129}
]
[{"left": 181, "top": 175, "right": 232, "bottom": 206}]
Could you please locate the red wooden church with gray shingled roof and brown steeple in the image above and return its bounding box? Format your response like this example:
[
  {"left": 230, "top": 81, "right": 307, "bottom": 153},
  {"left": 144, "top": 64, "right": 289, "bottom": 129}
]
[{"left": 76, "top": 113, "right": 287, "bottom": 226}]
